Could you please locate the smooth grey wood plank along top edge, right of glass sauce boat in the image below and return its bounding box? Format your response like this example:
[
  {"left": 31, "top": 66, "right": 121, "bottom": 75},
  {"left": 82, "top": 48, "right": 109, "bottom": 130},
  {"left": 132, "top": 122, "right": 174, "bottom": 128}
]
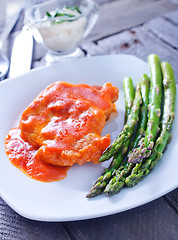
[{"left": 88, "top": 0, "right": 178, "bottom": 40}]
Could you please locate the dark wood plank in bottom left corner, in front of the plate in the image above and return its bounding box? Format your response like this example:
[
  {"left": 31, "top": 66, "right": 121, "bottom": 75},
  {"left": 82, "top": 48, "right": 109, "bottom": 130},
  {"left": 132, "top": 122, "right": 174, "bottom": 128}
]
[{"left": 0, "top": 198, "right": 71, "bottom": 240}]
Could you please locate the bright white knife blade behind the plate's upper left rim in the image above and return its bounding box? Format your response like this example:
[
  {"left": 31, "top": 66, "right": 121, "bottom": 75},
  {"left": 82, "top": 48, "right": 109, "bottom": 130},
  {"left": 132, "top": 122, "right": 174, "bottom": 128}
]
[{"left": 9, "top": 29, "right": 34, "bottom": 78}]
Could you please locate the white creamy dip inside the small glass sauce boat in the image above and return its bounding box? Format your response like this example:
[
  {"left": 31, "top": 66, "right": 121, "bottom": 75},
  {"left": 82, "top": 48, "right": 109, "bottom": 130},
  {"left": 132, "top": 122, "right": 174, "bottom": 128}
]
[{"left": 33, "top": 7, "right": 87, "bottom": 53}]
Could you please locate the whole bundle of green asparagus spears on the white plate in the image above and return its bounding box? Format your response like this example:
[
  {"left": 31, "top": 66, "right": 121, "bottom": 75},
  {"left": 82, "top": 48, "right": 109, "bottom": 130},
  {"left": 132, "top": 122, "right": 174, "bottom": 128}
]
[{"left": 86, "top": 54, "right": 176, "bottom": 198}]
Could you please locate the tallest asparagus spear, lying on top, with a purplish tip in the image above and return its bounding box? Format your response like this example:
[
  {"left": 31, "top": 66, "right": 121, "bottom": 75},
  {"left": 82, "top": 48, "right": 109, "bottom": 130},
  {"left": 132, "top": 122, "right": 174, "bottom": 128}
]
[{"left": 128, "top": 54, "right": 162, "bottom": 162}]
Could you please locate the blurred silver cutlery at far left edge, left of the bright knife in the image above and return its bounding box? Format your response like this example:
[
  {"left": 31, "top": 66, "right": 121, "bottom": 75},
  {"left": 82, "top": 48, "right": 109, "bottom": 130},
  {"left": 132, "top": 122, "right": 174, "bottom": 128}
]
[{"left": 0, "top": 3, "right": 22, "bottom": 80}]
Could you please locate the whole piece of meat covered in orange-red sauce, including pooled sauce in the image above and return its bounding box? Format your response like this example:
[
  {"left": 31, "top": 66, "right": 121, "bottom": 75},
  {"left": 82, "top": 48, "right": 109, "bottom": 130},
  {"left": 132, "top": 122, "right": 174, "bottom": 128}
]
[{"left": 5, "top": 82, "right": 118, "bottom": 182}]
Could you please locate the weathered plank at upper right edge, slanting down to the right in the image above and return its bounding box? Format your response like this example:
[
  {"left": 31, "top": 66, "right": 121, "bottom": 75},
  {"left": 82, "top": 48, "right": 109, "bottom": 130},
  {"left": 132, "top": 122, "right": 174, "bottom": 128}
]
[{"left": 144, "top": 14, "right": 178, "bottom": 49}]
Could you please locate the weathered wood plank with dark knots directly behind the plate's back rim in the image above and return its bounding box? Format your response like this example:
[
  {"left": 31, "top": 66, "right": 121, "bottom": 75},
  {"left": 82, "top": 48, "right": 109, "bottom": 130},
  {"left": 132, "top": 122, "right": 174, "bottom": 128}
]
[{"left": 82, "top": 26, "right": 178, "bottom": 82}]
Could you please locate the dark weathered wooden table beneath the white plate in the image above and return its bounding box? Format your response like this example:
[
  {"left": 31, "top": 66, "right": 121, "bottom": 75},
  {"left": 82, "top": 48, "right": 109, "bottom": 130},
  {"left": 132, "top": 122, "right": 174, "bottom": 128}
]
[{"left": 0, "top": 0, "right": 178, "bottom": 240}]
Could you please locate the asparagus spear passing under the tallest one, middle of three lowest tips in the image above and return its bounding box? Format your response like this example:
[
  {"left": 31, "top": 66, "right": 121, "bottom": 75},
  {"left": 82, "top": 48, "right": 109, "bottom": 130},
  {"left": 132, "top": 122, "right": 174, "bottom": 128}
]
[{"left": 104, "top": 74, "right": 149, "bottom": 196}]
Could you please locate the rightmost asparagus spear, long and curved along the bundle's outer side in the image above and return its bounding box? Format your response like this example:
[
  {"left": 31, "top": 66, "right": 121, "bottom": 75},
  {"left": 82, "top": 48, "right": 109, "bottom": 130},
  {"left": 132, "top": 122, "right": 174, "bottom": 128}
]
[{"left": 125, "top": 62, "right": 176, "bottom": 187}]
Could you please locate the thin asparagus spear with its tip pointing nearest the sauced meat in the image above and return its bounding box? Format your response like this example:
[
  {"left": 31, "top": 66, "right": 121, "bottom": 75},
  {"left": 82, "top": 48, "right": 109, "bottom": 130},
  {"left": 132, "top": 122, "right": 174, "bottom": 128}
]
[{"left": 99, "top": 81, "right": 142, "bottom": 162}]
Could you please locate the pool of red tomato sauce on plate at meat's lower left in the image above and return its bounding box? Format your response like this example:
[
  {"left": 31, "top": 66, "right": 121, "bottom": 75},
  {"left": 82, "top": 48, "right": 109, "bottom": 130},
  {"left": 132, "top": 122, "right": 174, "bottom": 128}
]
[{"left": 5, "top": 128, "right": 69, "bottom": 182}]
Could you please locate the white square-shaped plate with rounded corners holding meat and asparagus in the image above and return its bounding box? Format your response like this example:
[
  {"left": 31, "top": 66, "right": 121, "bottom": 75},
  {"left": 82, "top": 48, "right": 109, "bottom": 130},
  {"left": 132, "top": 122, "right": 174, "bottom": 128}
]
[{"left": 0, "top": 55, "right": 178, "bottom": 221}]
